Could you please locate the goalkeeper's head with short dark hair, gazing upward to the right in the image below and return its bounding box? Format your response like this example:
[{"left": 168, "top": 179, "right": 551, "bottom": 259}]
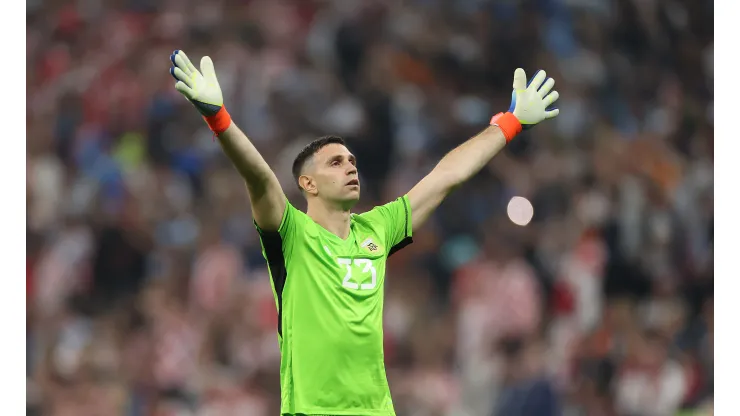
[{"left": 300, "top": 143, "right": 360, "bottom": 209}]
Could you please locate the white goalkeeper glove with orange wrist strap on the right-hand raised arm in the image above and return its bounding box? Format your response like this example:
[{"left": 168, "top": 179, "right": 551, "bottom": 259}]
[{"left": 491, "top": 68, "right": 560, "bottom": 142}]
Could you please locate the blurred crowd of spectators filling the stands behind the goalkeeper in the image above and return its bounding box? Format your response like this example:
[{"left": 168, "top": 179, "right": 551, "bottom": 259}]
[{"left": 26, "top": 0, "right": 714, "bottom": 416}]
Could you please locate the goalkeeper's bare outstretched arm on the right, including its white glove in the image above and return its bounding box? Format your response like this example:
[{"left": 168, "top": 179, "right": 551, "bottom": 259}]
[{"left": 408, "top": 68, "right": 560, "bottom": 230}]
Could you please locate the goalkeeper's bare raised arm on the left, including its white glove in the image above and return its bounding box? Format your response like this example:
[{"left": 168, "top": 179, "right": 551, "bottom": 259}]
[{"left": 170, "top": 51, "right": 286, "bottom": 231}]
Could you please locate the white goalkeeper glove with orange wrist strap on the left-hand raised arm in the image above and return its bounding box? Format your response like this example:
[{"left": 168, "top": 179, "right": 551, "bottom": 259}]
[{"left": 170, "top": 50, "right": 231, "bottom": 135}]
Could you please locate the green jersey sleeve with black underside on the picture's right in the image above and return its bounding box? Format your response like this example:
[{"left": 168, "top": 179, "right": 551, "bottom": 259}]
[{"left": 367, "top": 195, "right": 413, "bottom": 256}]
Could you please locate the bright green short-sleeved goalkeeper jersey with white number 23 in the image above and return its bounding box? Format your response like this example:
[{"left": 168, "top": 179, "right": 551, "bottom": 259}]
[{"left": 258, "top": 196, "right": 411, "bottom": 416}]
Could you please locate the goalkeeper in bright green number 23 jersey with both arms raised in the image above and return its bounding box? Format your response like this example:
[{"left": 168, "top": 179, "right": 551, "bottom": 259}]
[{"left": 170, "top": 51, "right": 559, "bottom": 416}]
